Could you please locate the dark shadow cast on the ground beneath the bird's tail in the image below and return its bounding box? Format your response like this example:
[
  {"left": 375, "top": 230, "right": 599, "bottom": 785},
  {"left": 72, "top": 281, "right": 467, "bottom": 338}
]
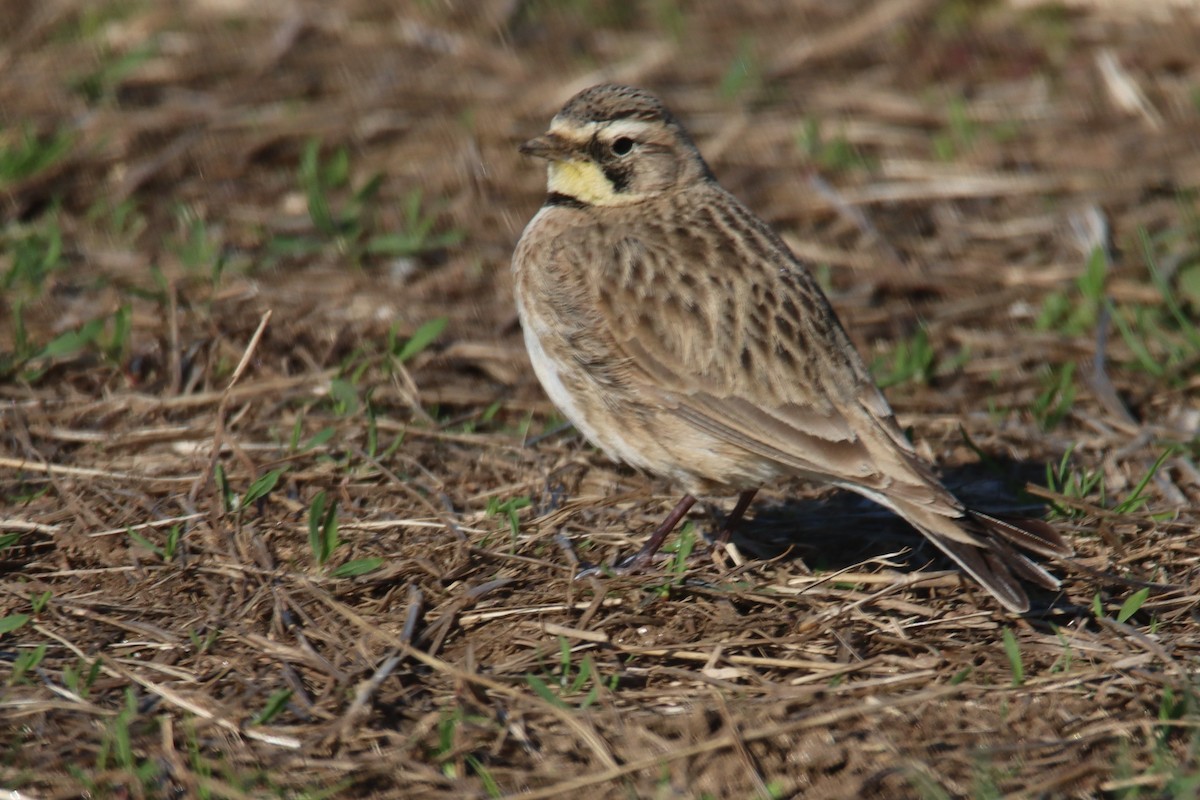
[{"left": 715, "top": 458, "right": 1046, "bottom": 582}]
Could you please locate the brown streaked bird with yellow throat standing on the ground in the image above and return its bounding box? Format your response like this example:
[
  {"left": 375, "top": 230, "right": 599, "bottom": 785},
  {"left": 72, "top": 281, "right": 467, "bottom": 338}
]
[{"left": 511, "top": 84, "right": 1073, "bottom": 614}]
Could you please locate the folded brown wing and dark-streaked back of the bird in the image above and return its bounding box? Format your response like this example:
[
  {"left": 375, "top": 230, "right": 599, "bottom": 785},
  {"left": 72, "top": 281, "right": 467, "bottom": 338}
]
[{"left": 593, "top": 204, "right": 940, "bottom": 506}]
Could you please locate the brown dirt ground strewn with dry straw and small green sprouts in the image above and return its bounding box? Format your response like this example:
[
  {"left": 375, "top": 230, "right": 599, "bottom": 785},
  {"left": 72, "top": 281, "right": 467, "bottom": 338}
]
[{"left": 0, "top": 0, "right": 1200, "bottom": 798}]
